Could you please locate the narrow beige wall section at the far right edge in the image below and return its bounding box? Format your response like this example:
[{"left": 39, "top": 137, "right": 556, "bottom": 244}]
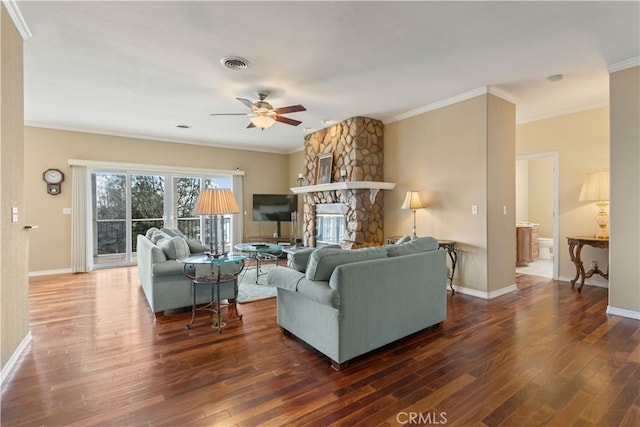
[{"left": 609, "top": 66, "right": 640, "bottom": 318}]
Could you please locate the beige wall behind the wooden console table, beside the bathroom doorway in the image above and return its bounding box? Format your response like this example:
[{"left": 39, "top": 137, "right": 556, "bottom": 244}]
[{"left": 516, "top": 107, "right": 609, "bottom": 283}]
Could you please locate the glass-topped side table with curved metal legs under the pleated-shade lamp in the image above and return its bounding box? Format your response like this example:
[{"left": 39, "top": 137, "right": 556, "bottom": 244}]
[{"left": 178, "top": 254, "right": 246, "bottom": 334}]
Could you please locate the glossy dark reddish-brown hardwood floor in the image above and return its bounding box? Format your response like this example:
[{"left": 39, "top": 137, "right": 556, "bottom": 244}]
[{"left": 1, "top": 268, "right": 640, "bottom": 426}]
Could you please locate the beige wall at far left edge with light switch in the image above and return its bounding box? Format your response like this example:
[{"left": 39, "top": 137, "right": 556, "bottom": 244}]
[{"left": 0, "top": 7, "right": 30, "bottom": 378}]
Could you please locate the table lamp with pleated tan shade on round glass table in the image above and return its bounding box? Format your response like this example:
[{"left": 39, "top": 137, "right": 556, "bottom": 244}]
[{"left": 194, "top": 188, "right": 240, "bottom": 258}]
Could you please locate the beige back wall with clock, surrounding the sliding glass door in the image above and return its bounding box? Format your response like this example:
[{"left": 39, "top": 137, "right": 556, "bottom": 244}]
[{"left": 24, "top": 127, "right": 292, "bottom": 272}]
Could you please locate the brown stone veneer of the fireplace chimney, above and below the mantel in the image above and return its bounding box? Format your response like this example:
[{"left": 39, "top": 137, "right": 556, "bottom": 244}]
[{"left": 303, "top": 117, "right": 384, "bottom": 248}]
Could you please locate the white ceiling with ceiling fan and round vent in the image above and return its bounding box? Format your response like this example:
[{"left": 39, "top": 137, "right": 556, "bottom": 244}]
[{"left": 17, "top": 1, "right": 640, "bottom": 152}]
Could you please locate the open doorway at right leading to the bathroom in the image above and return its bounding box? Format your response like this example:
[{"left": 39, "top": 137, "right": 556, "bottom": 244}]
[{"left": 516, "top": 152, "right": 559, "bottom": 280}]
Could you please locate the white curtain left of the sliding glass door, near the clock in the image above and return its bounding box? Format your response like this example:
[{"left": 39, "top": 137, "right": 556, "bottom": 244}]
[{"left": 71, "top": 165, "right": 93, "bottom": 273}]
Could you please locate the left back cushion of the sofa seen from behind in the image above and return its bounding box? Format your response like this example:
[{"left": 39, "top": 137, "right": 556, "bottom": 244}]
[{"left": 306, "top": 246, "right": 387, "bottom": 280}]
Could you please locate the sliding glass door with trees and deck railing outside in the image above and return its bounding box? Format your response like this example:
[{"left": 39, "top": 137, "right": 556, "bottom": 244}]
[{"left": 91, "top": 170, "right": 232, "bottom": 266}]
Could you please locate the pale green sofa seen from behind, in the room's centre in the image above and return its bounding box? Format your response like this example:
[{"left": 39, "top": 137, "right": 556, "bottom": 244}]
[{"left": 267, "top": 237, "right": 447, "bottom": 370}]
